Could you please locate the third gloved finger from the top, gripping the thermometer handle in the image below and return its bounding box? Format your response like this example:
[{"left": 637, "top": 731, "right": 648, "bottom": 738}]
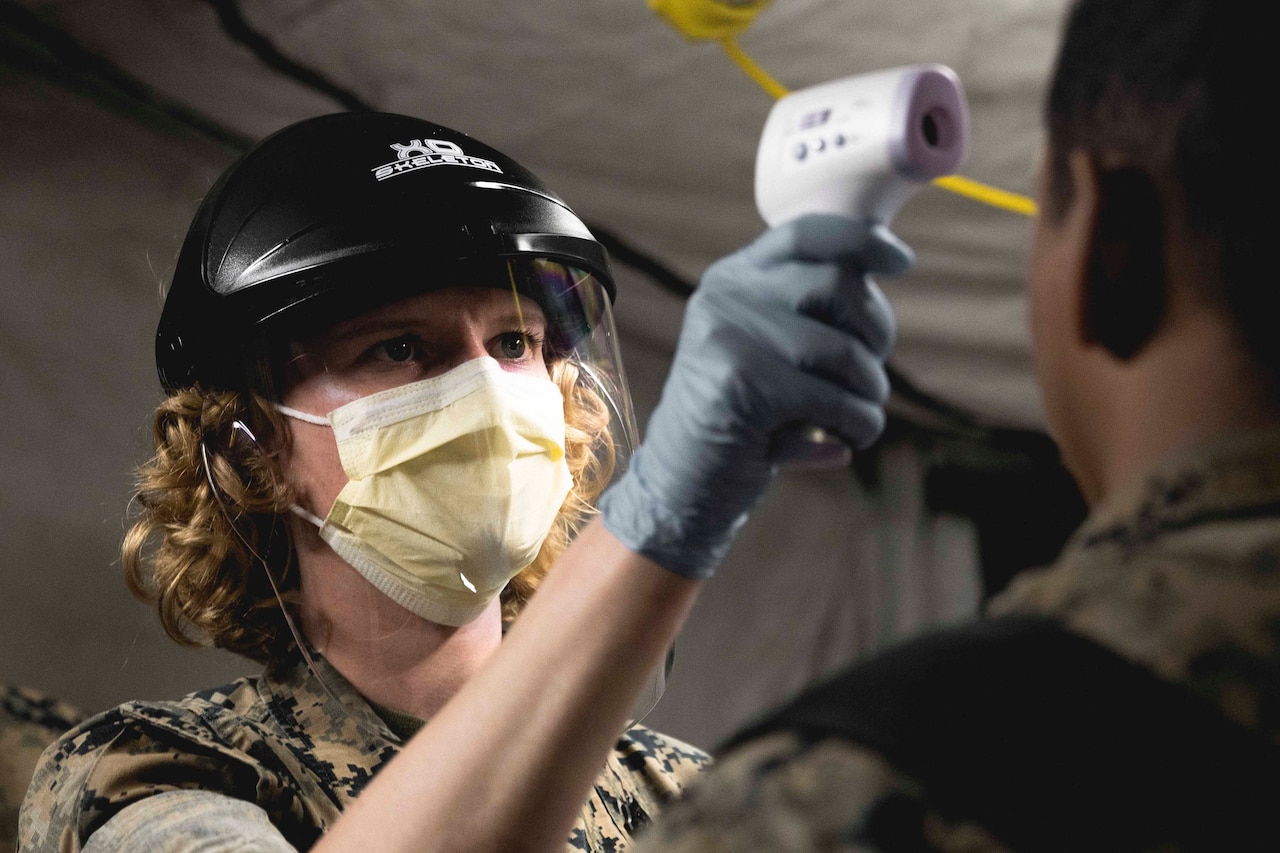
[{"left": 724, "top": 297, "right": 890, "bottom": 403}]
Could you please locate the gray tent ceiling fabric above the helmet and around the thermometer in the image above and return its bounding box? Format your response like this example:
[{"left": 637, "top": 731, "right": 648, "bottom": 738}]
[{"left": 10, "top": 0, "right": 1062, "bottom": 425}]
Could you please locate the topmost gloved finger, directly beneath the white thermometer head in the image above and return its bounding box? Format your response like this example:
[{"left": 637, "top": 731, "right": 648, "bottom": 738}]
[{"left": 739, "top": 214, "right": 915, "bottom": 275}]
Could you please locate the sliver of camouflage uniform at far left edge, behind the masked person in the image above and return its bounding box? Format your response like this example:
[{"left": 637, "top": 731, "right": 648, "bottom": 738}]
[{"left": 0, "top": 685, "right": 83, "bottom": 853}]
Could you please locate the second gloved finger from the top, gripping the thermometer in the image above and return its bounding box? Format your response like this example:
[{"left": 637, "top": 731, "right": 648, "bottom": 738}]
[{"left": 707, "top": 261, "right": 897, "bottom": 357}]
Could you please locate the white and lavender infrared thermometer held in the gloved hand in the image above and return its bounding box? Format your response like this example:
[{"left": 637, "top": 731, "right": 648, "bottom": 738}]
[{"left": 755, "top": 64, "right": 969, "bottom": 465}]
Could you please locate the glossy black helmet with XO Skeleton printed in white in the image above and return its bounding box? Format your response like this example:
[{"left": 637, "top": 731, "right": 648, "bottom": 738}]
[{"left": 156, "top": 113, "right": 614, "bottom": 392}]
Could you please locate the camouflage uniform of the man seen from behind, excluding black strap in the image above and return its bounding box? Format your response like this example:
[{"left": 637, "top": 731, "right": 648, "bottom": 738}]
[{"left": 636, "top": 432, "right": 1280, "bottom": 853}]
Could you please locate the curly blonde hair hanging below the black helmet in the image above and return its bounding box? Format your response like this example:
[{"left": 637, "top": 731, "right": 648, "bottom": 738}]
[{"left": 120, "top": 360, "right": 617, "bottom": 663}]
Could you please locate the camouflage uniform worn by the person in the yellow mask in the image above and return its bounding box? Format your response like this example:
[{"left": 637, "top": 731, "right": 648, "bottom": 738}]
[{"left": 19, "top": 648, "right": 707, "bottom": 853}]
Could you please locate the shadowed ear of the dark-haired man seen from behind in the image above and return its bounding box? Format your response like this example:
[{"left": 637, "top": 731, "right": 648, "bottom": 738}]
[{"left": 1071, "top": 158, "right": 1166, "bottom": 360}]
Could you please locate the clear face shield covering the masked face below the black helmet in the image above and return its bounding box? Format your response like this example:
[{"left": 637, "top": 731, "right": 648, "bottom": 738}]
[{"left": 252, "top": 256, "right": 669, "bottom": 721}]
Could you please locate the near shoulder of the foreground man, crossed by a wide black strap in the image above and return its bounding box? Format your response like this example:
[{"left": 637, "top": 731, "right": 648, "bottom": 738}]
[{"left": 640, "top": 617, "right": 1280, "bottom": 852}]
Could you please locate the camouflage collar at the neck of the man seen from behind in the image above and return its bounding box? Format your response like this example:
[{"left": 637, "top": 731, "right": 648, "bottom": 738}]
[{"left": 1066, "top": 429, "right": 1280, "bottom": 553}]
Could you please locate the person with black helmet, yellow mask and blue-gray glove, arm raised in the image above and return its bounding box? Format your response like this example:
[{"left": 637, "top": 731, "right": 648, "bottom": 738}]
[{"left": 20, "top": 114, "right": 906, "bottom": 850}]
